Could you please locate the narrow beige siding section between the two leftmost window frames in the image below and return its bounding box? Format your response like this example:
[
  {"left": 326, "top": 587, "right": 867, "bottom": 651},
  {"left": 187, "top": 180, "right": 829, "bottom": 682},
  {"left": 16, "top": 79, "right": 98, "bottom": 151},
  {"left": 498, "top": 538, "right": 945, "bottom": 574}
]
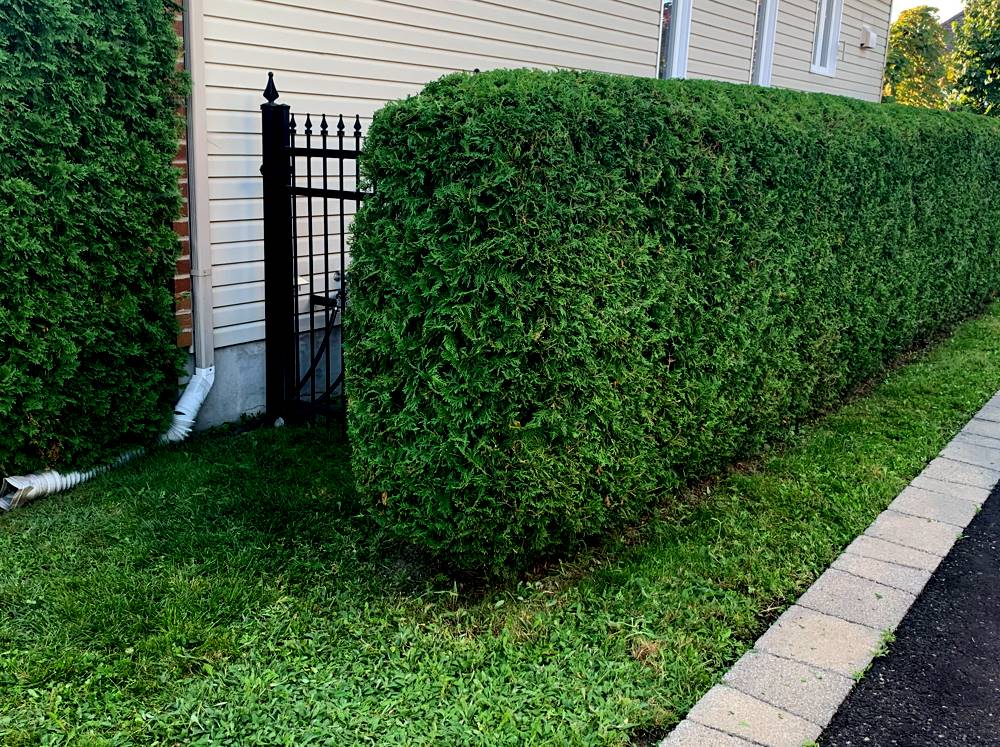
[{"left": 688, "top": 0, "right": 757, "bottom": 83}]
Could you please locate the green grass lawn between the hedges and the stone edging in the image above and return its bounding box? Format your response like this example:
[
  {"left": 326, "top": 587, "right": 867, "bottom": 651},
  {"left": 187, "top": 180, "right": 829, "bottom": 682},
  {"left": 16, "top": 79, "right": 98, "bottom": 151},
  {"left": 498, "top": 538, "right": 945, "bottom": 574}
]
[{"left": 0, "top": 305, "right": 1000, "bottom": 745}]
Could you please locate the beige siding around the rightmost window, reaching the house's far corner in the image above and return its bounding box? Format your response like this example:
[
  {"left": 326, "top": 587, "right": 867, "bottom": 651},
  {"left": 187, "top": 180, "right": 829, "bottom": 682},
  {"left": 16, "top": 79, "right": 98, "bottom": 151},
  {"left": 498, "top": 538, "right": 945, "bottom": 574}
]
[{"left": 764, "top": 0, "right": 890, "bottom": 101}]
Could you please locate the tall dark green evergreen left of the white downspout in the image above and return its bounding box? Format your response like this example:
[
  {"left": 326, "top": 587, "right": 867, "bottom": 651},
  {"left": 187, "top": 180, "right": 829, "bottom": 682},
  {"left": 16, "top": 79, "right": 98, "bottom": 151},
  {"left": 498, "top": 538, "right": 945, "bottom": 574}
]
[{"left": 0, "top": 0, "right": 182, "bottom": 474}]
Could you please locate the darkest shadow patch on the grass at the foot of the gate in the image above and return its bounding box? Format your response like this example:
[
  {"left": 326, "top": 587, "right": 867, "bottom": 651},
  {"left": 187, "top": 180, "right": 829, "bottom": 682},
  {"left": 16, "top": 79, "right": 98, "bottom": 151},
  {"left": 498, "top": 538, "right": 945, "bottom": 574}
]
[{"left": 126, "top": 425, "right": 454, "bottom": 593}]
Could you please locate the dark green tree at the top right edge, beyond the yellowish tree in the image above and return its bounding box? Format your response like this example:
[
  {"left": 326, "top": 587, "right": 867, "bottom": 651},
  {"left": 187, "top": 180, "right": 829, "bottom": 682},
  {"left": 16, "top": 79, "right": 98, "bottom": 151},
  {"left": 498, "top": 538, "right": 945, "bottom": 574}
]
[{"left": 952, "top": 0, "right": 1000, "bottom": 116}]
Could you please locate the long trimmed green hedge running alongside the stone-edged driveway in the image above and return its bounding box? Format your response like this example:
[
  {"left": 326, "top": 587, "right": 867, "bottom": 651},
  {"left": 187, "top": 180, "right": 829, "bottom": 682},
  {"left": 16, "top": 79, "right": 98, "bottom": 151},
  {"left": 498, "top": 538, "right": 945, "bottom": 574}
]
[{"left": 346, "top": 70, "right": 1000, "bottom": 571}]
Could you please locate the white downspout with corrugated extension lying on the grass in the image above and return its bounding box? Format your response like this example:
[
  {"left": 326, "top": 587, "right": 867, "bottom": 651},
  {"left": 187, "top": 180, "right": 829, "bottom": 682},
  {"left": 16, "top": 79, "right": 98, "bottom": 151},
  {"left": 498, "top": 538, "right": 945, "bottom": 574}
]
[{"left": 0, "top": 0, "right": 215, "bottom": 511}]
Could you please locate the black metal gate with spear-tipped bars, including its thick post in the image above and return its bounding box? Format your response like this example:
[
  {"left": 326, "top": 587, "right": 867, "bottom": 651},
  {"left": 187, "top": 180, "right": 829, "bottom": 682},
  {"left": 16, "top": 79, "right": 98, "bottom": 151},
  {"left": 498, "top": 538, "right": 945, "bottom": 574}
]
[{"left": 260, "top": 73, "right": 366, "bottom": 426}]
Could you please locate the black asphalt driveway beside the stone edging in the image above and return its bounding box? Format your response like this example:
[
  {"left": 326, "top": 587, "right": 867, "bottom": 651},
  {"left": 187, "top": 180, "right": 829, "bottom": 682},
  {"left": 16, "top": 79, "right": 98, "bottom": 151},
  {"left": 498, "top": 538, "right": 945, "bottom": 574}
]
[{"left": 820, "top": 488, "right": 1000, "bottom": 747}]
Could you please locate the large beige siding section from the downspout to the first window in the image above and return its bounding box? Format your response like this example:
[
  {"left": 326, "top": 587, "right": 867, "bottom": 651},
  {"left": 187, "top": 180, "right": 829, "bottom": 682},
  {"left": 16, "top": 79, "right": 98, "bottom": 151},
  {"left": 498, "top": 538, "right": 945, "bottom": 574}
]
[{"left": 204, "top": 0, "right": 660, "bottom": 347}]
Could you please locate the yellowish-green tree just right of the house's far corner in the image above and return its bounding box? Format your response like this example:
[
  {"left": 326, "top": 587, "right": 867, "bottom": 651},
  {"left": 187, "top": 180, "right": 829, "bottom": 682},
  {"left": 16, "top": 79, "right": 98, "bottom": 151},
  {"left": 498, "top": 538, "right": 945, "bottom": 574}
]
[{"left": 883, "top": 5, "right": 946, "bottom": 109}]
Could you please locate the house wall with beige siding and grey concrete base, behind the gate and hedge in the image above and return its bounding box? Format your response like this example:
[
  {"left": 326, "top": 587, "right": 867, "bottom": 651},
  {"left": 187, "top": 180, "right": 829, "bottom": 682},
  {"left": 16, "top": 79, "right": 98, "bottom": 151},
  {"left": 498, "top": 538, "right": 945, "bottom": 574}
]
[{"left": 184, "top": 0, "right": 890, "bottom": 425}]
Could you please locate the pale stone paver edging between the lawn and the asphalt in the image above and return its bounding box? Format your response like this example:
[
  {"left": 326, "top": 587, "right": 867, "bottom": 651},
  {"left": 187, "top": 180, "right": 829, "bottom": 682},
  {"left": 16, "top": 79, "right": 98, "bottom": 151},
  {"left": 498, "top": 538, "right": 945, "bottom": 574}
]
[{"left": 660, "top": 393, "right": 1000, "bottom": 747}]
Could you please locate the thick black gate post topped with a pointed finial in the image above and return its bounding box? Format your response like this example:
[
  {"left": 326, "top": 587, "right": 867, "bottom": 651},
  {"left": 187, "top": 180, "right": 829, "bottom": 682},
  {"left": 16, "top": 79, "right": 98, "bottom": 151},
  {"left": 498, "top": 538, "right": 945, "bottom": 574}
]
[{"left": 260, "top": 73, "right": 297, "bottom": 419}]
